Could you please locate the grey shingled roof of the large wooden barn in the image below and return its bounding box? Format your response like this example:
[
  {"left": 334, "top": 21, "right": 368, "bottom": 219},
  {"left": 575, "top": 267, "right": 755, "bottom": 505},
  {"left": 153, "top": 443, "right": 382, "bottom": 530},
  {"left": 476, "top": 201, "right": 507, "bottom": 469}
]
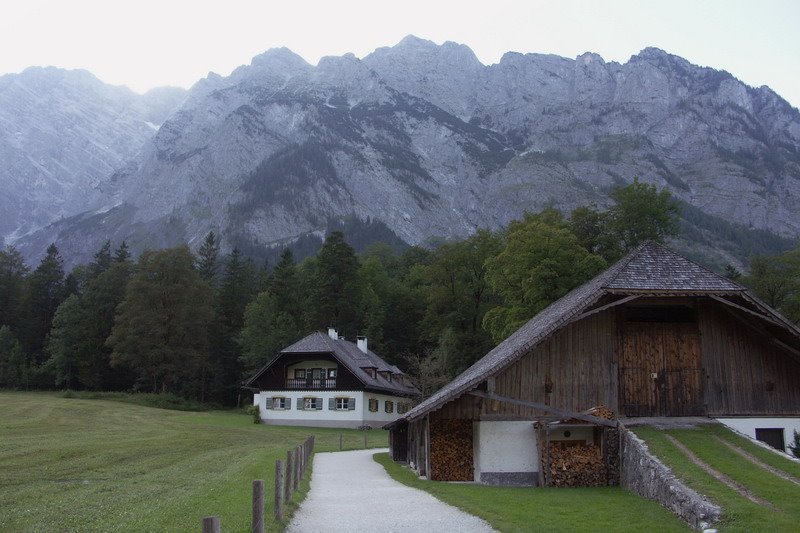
[{"left": 393, "top": 242, "right": 800, "bottom": 424}]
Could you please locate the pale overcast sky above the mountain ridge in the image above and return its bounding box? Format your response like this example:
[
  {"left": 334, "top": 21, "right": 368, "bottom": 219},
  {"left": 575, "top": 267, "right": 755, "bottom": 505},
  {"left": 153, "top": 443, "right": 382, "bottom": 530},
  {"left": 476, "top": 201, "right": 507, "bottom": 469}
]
[{"left": 0, "top": 0, "right": 800, "bottom": 107}]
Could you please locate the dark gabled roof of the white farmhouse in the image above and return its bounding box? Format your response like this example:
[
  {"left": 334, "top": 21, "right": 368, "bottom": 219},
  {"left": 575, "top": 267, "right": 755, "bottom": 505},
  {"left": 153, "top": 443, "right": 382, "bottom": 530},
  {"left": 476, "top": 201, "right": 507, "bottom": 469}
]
[{"left": 245, "top": 331, "right": 420, "bottom": 396}]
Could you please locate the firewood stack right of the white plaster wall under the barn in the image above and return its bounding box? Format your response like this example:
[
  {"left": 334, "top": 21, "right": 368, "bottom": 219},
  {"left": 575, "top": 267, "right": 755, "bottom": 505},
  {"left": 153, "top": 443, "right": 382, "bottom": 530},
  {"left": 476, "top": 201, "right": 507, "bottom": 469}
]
[{"left": 548, "top": 441, "right": 608, "bottom": 487}]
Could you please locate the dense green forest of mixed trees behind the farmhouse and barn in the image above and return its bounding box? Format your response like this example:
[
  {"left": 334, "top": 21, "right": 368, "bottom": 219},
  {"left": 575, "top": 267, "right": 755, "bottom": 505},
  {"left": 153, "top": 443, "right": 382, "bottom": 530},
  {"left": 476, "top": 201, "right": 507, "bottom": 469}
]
[{"left": 0, "top": 181, "right": 800, "bottom": 405}]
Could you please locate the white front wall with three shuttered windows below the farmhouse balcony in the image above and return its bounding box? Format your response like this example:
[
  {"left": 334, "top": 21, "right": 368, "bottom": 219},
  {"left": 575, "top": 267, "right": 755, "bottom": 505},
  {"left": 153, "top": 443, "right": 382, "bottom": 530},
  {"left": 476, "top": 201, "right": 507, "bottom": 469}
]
[{"left": 254, "top": 390, "right": 364, "bottom": 427}]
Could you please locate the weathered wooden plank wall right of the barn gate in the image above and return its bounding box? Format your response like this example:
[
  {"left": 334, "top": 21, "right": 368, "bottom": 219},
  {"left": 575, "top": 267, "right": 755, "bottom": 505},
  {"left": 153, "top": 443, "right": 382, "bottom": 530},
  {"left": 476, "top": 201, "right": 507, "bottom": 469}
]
[{"left": 699, "top": 301, "right": 800, "bottom": 416}]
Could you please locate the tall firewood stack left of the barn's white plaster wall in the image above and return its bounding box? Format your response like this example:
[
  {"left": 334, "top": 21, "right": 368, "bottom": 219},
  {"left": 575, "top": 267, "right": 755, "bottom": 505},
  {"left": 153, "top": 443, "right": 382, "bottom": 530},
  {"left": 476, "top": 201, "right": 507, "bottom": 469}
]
[{"left": 430, "top": 419, "right": 474, "bottom": 481}]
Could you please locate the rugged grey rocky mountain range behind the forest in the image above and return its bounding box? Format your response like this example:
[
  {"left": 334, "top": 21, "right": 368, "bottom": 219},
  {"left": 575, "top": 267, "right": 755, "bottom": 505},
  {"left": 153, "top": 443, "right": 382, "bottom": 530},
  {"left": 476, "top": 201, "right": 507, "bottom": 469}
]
[{"left": 0, "top": 36, "right": 800, "bottom": 263}]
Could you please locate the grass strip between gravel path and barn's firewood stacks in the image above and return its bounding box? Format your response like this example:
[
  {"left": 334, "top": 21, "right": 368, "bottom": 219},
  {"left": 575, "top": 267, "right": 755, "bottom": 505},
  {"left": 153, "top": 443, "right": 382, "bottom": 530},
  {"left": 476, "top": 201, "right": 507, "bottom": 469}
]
[{"left": 375, "top": 453, "right": 690, "bottom": 532}]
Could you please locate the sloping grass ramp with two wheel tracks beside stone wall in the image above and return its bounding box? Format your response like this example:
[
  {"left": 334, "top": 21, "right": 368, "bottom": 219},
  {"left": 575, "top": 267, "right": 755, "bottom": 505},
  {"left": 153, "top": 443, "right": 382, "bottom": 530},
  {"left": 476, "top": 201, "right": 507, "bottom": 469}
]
[{"left": 634, "top": 426, "right": 800, "bottom": 531}]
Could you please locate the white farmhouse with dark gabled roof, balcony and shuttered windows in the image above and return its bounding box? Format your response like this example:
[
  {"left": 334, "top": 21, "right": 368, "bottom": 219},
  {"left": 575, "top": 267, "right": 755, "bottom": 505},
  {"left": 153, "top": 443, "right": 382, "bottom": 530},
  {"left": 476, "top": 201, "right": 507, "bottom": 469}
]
[{"left": 245, "top": 328, "right": 419, "bottom": 428}]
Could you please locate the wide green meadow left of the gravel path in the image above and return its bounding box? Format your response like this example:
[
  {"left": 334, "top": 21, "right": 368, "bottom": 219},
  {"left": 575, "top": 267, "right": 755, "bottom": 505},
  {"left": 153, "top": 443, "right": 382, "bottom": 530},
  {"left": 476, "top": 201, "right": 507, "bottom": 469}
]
[{"left": 0, "top": 392, "right": 387, "bottom": 531}]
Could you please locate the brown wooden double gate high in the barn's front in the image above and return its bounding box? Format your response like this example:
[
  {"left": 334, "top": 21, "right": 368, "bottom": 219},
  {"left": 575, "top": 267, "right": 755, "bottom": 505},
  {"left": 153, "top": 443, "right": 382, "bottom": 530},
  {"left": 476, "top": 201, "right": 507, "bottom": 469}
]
[{"left": 619, "top": 323, "right": 705, "bottom": 416}]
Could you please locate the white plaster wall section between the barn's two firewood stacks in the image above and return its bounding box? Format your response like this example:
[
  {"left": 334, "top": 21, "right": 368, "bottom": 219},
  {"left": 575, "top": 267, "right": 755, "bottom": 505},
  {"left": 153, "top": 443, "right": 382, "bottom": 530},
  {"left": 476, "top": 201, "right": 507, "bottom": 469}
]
[{"left": 473, "top": 420, "right": 539, "bottom": 479}]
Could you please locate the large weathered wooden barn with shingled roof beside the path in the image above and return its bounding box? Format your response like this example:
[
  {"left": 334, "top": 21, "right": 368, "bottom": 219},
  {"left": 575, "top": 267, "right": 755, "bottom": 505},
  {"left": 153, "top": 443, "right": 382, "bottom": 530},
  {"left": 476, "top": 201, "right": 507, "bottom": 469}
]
[{"left": 389, "top": 243, "right": 800, "bottom": 485}]
